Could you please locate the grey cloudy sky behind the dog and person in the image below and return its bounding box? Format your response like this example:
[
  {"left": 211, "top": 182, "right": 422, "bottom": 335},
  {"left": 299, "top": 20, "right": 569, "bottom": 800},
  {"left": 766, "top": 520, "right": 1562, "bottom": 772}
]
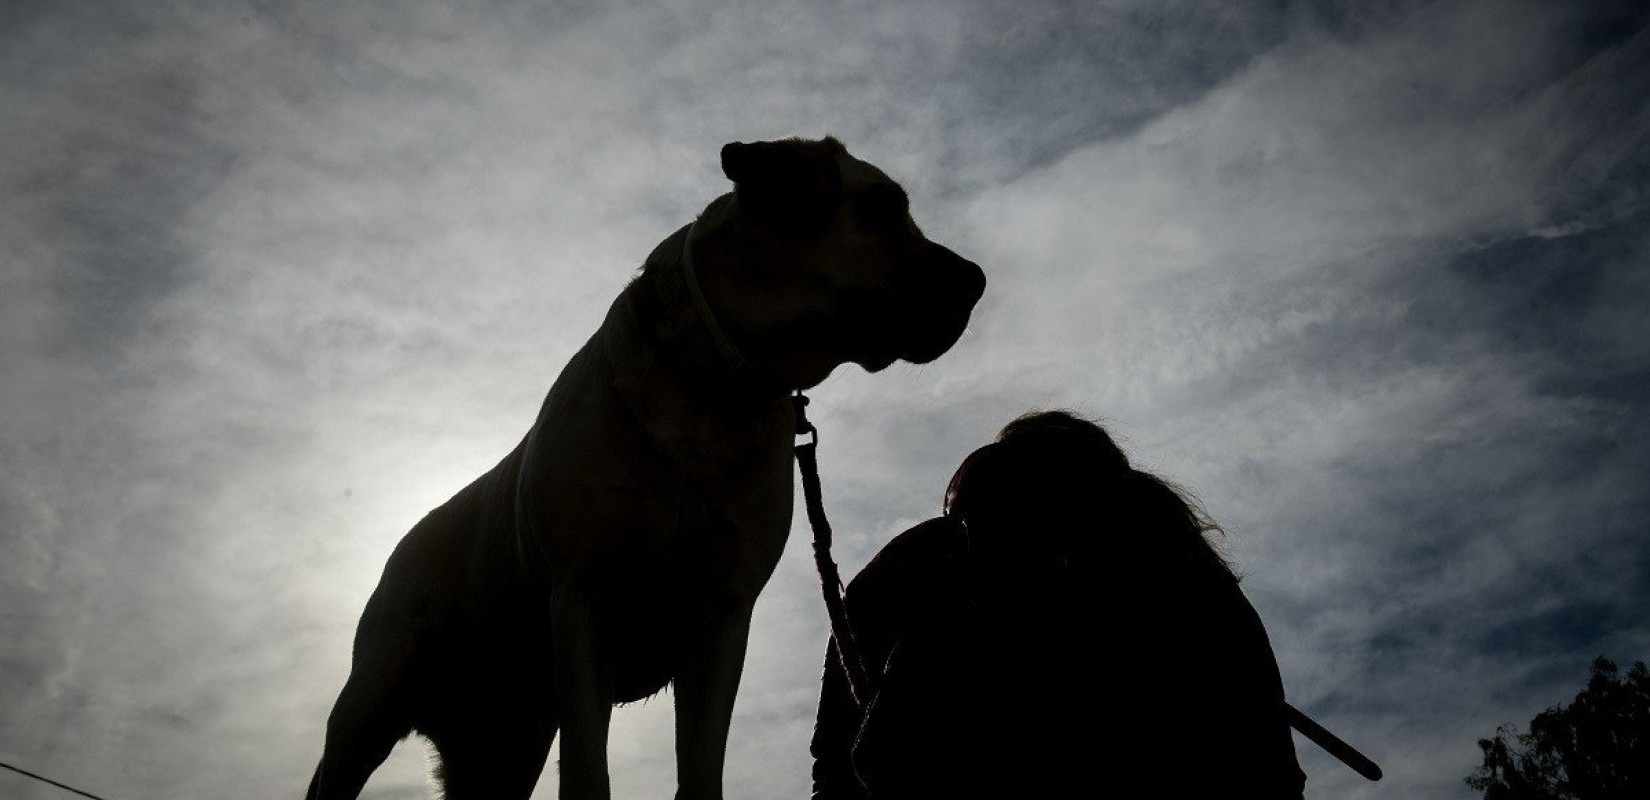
[{"left": 0, "top": 0, "right": 1650, "bottom": 800}]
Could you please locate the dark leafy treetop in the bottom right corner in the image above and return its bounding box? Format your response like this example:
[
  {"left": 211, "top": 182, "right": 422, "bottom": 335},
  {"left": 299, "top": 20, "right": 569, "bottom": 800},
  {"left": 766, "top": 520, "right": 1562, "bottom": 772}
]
[{"left": 1467, "top": 656, "right": 1650, "bottom": 800}]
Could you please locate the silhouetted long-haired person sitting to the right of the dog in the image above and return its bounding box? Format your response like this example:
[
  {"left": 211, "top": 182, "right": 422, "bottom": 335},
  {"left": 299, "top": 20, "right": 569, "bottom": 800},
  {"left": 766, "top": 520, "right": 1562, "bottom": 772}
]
[{"left": 810, "top": 411, "right": 1305, "bottom": 800}]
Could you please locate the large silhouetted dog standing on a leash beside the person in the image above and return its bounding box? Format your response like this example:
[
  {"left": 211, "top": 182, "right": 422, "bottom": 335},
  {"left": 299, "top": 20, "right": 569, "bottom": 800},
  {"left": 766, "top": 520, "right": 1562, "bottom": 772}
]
[{"left": 307, "top": 137, "right": 985, "bottom": 800}]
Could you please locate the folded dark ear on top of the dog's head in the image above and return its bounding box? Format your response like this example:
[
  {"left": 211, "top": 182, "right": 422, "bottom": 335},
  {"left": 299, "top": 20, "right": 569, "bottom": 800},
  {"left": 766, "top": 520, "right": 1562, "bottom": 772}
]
[{"left": 721, "top": 139, "right": 843, "bottom": 231}]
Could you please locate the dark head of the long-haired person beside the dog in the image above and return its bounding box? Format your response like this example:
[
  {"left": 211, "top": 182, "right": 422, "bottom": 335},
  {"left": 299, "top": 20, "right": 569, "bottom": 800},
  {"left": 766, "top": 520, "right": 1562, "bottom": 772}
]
[{"left": 945, "top": 411, "right": 1228, "bottom": 571}]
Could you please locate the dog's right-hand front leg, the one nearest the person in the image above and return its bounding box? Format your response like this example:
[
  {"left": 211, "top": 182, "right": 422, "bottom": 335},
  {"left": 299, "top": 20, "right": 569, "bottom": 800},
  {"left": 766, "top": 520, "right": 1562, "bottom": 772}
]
[{"left": 677, "top": 600, "right": 752, "bottom": 800}]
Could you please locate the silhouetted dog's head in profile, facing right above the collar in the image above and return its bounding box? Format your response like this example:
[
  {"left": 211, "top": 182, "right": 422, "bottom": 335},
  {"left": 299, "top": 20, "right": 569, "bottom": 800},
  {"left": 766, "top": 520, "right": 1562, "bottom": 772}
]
[{"left": 690, "top": 139, "right": 985, "bottom": 388}]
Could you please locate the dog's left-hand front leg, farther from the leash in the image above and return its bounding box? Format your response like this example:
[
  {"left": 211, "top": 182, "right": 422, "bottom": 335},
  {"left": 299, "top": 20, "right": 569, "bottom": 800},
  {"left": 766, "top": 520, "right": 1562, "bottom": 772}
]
[{"left": 549, "top": 576, "right": 614, "bottom": 800}]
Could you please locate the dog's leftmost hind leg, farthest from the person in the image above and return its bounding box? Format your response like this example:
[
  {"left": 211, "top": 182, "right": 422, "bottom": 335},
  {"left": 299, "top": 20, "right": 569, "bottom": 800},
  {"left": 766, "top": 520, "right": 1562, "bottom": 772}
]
[{"left": 304, "top": 671, "right": 413, "bottom": 800}]
